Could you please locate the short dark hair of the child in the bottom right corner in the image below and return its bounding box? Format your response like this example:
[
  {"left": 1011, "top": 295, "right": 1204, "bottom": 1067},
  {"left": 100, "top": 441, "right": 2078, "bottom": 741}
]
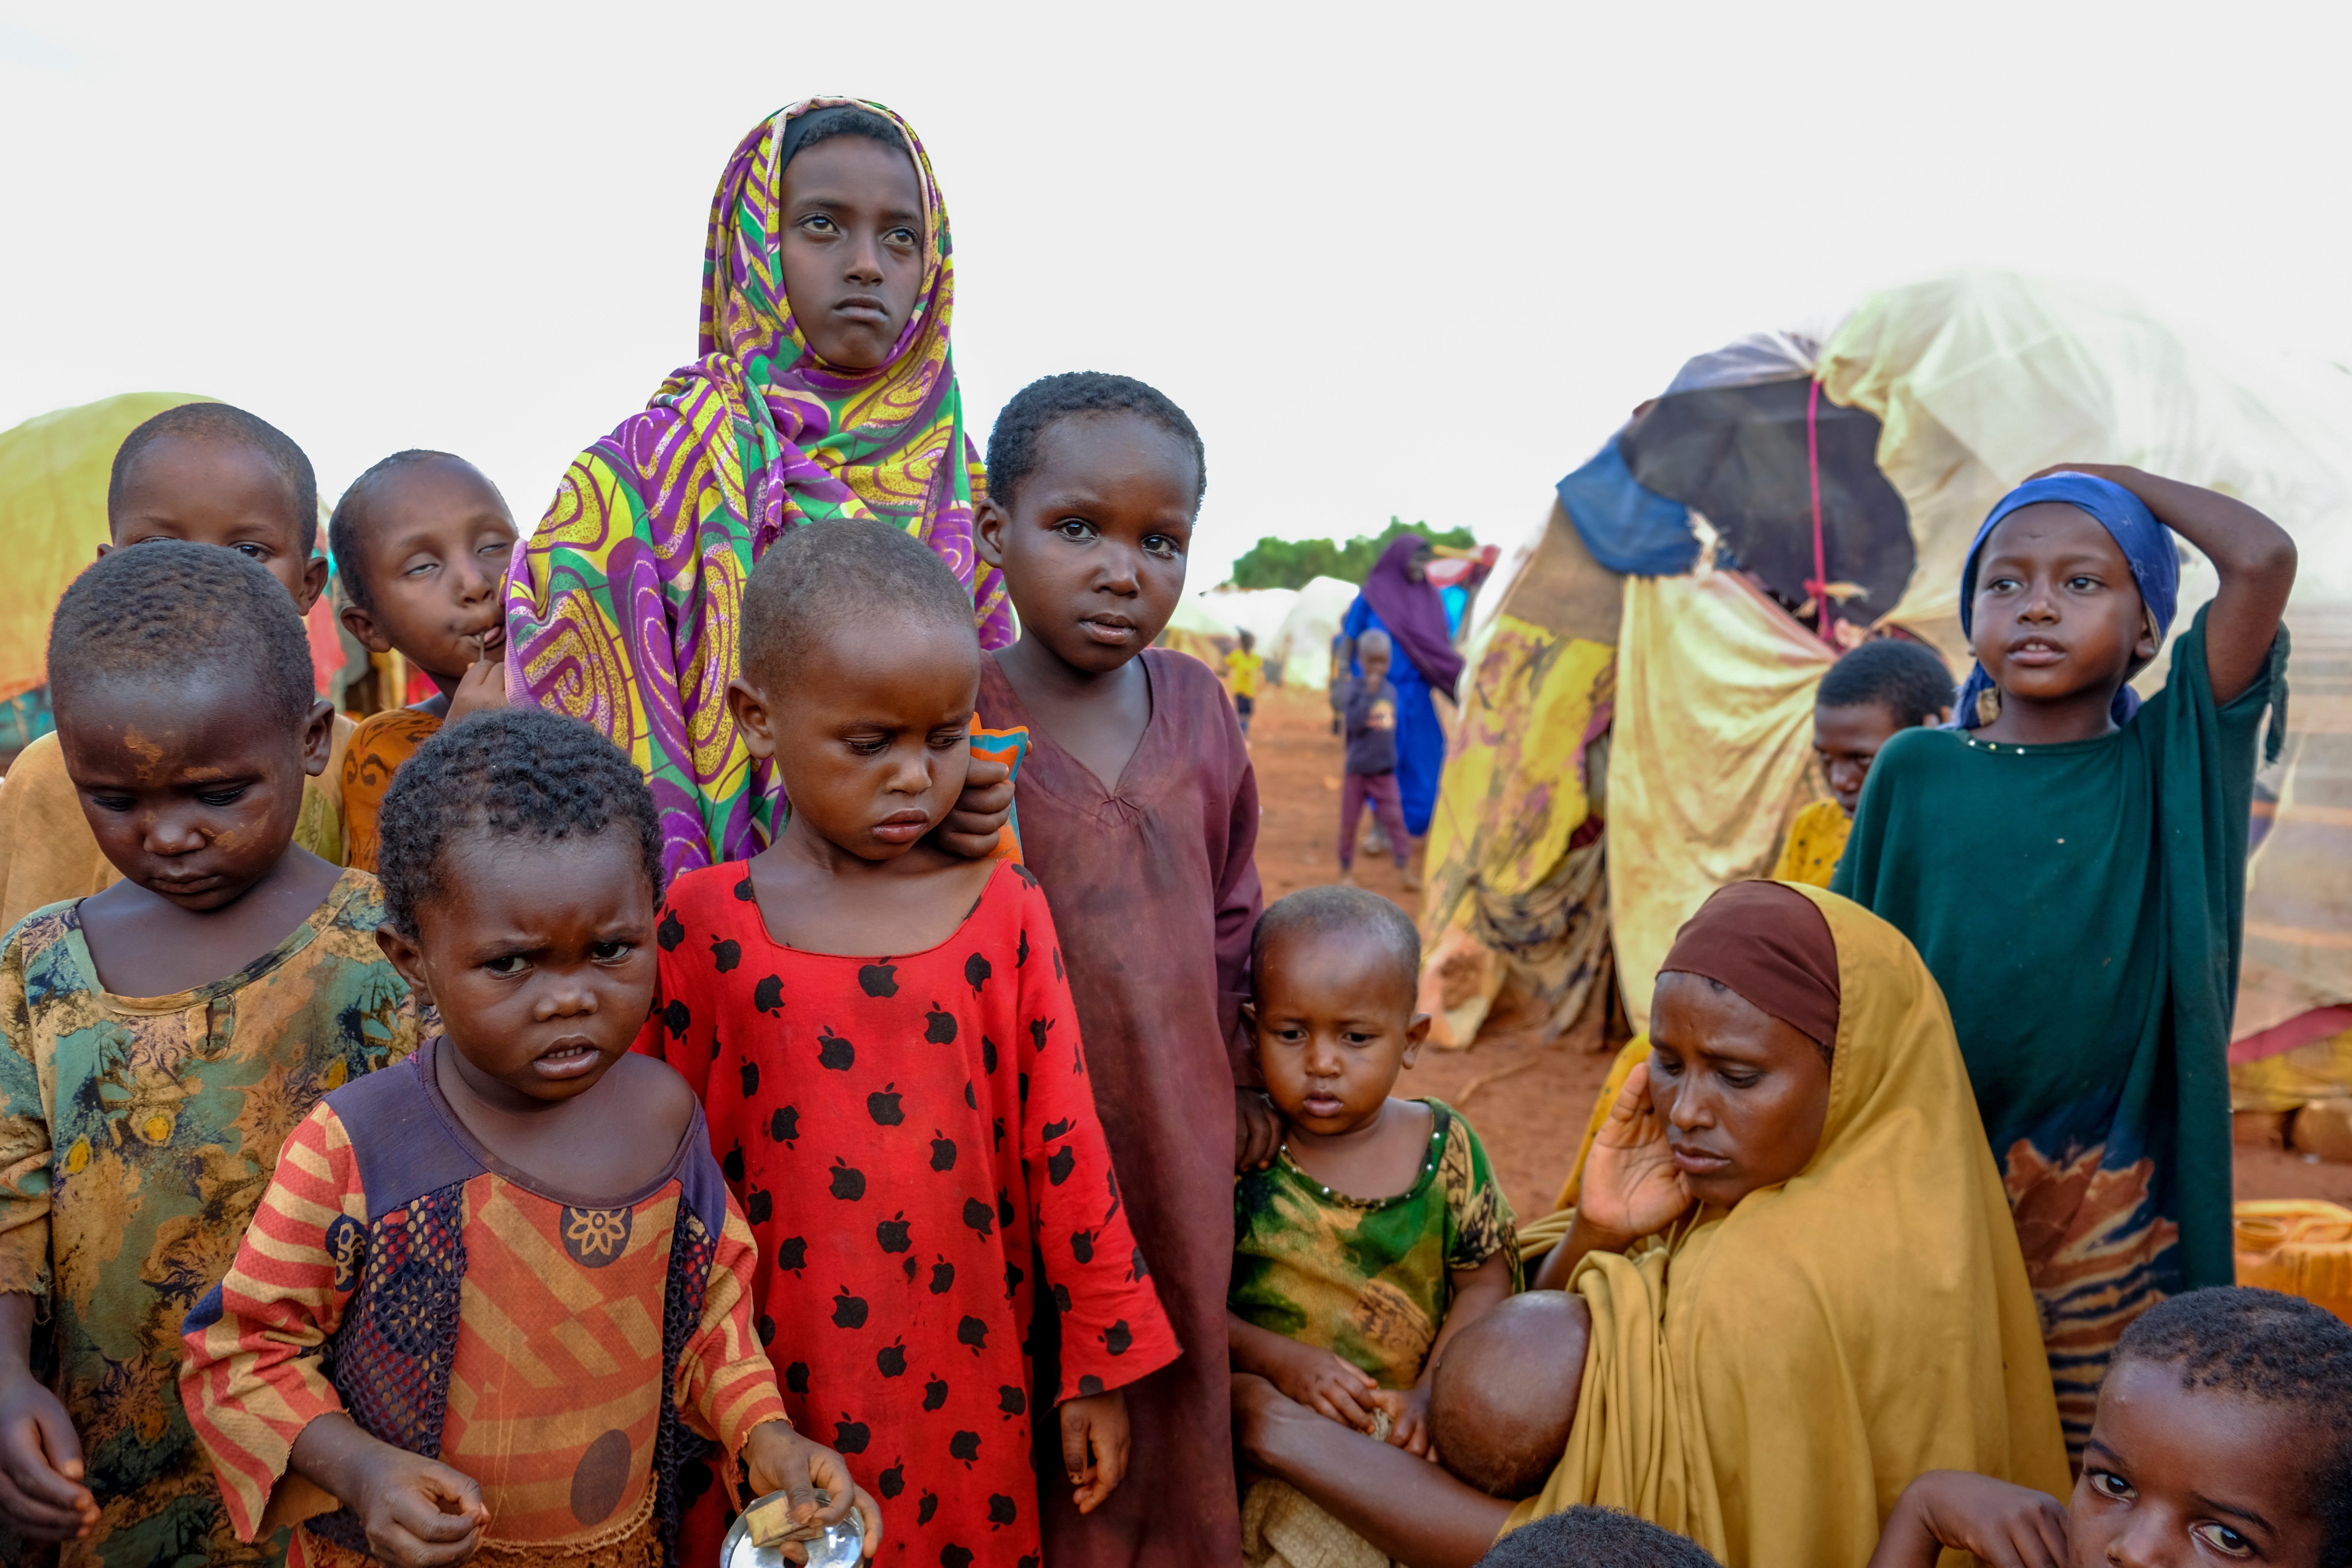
[{"left": 2107, "top": 1286, "right": 2352, "bottom": 1563}]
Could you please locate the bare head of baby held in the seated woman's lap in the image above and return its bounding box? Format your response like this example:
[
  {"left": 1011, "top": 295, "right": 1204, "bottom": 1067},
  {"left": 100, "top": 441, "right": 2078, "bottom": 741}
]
[{"left": 1430, "top": 1291, "right": 1592, "bottom": 1500}]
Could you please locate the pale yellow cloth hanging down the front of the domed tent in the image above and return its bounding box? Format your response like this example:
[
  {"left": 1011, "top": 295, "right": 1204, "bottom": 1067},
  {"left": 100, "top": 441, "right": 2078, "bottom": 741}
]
[{"left": 1609, "top": 571, "right": 1832, "bottom": 1030}]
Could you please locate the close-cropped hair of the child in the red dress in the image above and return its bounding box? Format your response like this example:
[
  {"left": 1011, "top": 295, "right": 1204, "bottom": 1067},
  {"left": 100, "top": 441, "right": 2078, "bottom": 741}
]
[{"left": 741, "top": 517, "right": 979, "bottom": 684}]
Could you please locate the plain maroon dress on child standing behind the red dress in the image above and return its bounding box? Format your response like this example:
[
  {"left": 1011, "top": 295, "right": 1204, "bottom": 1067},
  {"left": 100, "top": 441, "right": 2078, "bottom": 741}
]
[{"left": 981, "top": 649, "right": 1261, "bottom": 1568}]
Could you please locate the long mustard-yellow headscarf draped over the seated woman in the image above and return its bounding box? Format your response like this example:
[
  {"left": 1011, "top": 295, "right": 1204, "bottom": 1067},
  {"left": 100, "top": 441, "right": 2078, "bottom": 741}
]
[{"left": 1508, "top": 884, "right": 2070, "bottom": 1568}]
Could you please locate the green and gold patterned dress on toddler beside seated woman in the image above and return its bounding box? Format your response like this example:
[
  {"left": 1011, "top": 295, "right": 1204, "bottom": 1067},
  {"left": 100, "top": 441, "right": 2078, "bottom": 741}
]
[{"left": 1230, "top": 1100, "right": 1520, "bottom": 1389}]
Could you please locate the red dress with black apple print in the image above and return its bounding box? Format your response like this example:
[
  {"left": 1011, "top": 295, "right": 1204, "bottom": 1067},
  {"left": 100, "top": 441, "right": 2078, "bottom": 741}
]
[{"left": 638, "top": 861, "right": 1178, "bottom": 1568}]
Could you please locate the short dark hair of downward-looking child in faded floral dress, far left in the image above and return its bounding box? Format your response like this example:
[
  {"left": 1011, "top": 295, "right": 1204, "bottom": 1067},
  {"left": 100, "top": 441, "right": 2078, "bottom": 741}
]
[{"left": 49, "top": 538, "right": 315, "bottom": 734}]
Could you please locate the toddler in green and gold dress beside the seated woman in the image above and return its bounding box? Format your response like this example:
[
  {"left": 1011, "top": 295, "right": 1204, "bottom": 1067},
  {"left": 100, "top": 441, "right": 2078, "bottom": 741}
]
[{"left": 1228, "top": 886, "right": 1520, "bottom": 1458}]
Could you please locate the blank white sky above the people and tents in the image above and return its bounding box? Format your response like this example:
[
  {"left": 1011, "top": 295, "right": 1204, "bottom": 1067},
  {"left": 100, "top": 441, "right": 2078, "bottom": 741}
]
[{"left": 0, "top": 0, "right": 2352, "bottom": 588}]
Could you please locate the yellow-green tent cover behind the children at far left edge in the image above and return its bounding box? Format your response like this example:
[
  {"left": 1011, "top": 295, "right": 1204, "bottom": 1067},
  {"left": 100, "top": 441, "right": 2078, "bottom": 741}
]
[{"left": 0, "top": 393, "right": 209, "bottom": 698}]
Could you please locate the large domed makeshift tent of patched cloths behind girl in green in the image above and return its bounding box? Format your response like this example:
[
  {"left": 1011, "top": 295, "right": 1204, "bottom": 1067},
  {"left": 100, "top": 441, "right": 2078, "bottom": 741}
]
[{"left": 1423, "top": 273, "right": 2352, "bottom": 1053}]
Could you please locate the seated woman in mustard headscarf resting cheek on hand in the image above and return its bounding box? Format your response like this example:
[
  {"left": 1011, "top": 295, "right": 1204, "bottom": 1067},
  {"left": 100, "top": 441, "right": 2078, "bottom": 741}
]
[{"left": 1235, "top": 882, "right": 2067, "bottom": 1568}]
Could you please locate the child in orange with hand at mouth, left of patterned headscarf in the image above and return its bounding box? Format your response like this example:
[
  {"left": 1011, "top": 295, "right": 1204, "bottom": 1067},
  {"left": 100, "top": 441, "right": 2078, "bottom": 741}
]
[{"left": 327, "top": 451, "right": 515, "bottom": 870}]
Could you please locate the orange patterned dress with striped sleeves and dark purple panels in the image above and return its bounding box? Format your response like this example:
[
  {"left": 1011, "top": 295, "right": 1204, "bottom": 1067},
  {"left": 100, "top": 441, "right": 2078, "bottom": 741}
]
[{"left": 181, "top": 1041, "right": 783, "bottom": 1568}]
